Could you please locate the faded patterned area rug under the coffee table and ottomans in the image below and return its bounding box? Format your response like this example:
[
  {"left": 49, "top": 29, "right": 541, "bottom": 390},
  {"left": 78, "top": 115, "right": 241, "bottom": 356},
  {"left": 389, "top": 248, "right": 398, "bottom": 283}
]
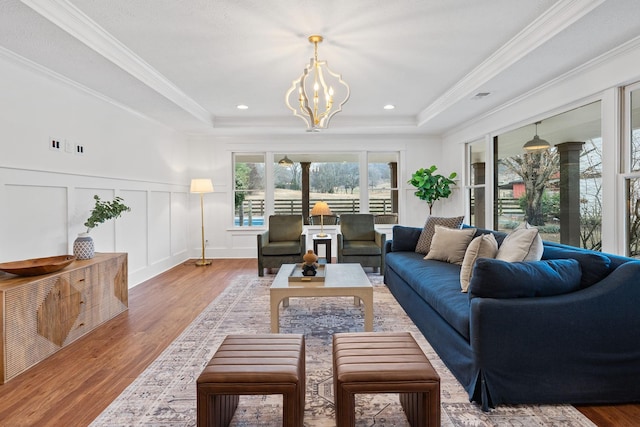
[{"left": 91, "top": 274, "right": 594, "bottom": 427}]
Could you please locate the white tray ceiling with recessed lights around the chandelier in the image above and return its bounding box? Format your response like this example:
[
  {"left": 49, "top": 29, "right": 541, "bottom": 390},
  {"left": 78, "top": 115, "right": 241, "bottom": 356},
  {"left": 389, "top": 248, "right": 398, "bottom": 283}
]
[{"left": 0, "top": 0, "right": 640, "bottom": 135}]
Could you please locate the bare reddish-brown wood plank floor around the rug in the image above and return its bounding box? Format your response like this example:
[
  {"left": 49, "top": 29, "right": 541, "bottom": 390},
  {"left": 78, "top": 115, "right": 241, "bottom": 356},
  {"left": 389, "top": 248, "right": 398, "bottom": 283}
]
[{"left": 0, "top": 259, "right": 640, "bottom": 427}]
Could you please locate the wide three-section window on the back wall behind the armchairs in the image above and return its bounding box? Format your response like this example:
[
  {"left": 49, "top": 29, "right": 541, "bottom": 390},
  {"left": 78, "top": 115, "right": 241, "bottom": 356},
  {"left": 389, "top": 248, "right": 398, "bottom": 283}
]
[{"left": 233, "top": 152, "right": 398, "bottom": 227}]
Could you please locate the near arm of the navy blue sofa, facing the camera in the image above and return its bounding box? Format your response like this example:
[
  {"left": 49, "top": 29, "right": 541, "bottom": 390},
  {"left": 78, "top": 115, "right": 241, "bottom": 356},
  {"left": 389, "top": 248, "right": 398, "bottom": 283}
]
[{"left": 467, "top": 261, "right": 640, "bottom": 408}]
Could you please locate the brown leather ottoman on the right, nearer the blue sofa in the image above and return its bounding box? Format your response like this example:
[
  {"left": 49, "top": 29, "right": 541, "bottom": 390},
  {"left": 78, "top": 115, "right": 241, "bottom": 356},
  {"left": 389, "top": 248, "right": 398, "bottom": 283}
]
[{"left": 333, "top": 332, "right": 440, "bottom": 427}]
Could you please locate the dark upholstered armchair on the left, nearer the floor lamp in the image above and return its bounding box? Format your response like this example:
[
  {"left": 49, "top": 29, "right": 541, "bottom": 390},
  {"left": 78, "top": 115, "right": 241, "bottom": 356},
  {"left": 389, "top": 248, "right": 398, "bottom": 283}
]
[{"left": 258, "top": 215, "right": 307, "bottom": 276}]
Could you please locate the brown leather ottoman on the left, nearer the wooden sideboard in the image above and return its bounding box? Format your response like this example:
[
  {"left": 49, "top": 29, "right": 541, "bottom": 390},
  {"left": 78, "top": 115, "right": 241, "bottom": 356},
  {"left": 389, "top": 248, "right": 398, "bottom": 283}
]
[{"left": 197, "top": 334, "right": 305, "bottom": 427}]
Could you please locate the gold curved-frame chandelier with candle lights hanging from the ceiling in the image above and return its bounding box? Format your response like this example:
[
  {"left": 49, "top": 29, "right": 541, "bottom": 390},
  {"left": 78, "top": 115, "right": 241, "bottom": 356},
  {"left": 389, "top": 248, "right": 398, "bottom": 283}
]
[{"left": 285, "top": 35, "right": 350, "bottom": 132}]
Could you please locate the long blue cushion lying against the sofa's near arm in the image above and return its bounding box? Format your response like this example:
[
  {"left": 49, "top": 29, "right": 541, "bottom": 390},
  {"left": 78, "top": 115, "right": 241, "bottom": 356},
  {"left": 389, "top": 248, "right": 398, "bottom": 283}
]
[{"left": 469, "top": 258, "right": 582, "bottom": 298}]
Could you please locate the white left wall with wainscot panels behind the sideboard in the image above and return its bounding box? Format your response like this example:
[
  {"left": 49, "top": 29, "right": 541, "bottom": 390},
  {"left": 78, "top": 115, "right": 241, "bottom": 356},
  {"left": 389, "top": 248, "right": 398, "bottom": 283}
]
[{"left": 0, "top": 56, "right": 190, "bottom": 286}]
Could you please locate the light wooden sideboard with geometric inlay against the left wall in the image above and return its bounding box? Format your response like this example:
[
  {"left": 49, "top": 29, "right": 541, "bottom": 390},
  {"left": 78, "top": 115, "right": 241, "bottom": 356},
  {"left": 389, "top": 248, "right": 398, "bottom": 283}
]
[{"left": 0, "top": 253, "right": 129, "bottom": 384}]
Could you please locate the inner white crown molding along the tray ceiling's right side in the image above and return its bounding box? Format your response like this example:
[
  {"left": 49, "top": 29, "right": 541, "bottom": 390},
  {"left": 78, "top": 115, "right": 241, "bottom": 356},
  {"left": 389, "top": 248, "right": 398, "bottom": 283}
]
[{"left": 417, "top": 0, "right": 605, "bottom": 126}]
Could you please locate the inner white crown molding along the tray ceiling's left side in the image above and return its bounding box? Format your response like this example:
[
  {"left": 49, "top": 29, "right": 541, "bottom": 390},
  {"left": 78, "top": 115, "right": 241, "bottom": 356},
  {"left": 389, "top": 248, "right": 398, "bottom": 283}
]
[{"left": 22, "top": 0, "right": 213, "bottom": 126}]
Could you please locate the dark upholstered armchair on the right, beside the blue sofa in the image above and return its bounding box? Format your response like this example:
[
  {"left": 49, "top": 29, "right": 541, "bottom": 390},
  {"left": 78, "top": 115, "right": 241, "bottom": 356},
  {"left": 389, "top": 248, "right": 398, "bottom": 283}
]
[{"left": 338, "top": 214, "right": 386, "bottom": 274}]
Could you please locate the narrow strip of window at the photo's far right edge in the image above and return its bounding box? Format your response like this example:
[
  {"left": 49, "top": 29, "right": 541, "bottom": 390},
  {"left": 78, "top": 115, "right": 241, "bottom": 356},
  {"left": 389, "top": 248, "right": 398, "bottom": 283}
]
[{"left": 625, "top": 84, "right": 640, "bottom": 258}]
